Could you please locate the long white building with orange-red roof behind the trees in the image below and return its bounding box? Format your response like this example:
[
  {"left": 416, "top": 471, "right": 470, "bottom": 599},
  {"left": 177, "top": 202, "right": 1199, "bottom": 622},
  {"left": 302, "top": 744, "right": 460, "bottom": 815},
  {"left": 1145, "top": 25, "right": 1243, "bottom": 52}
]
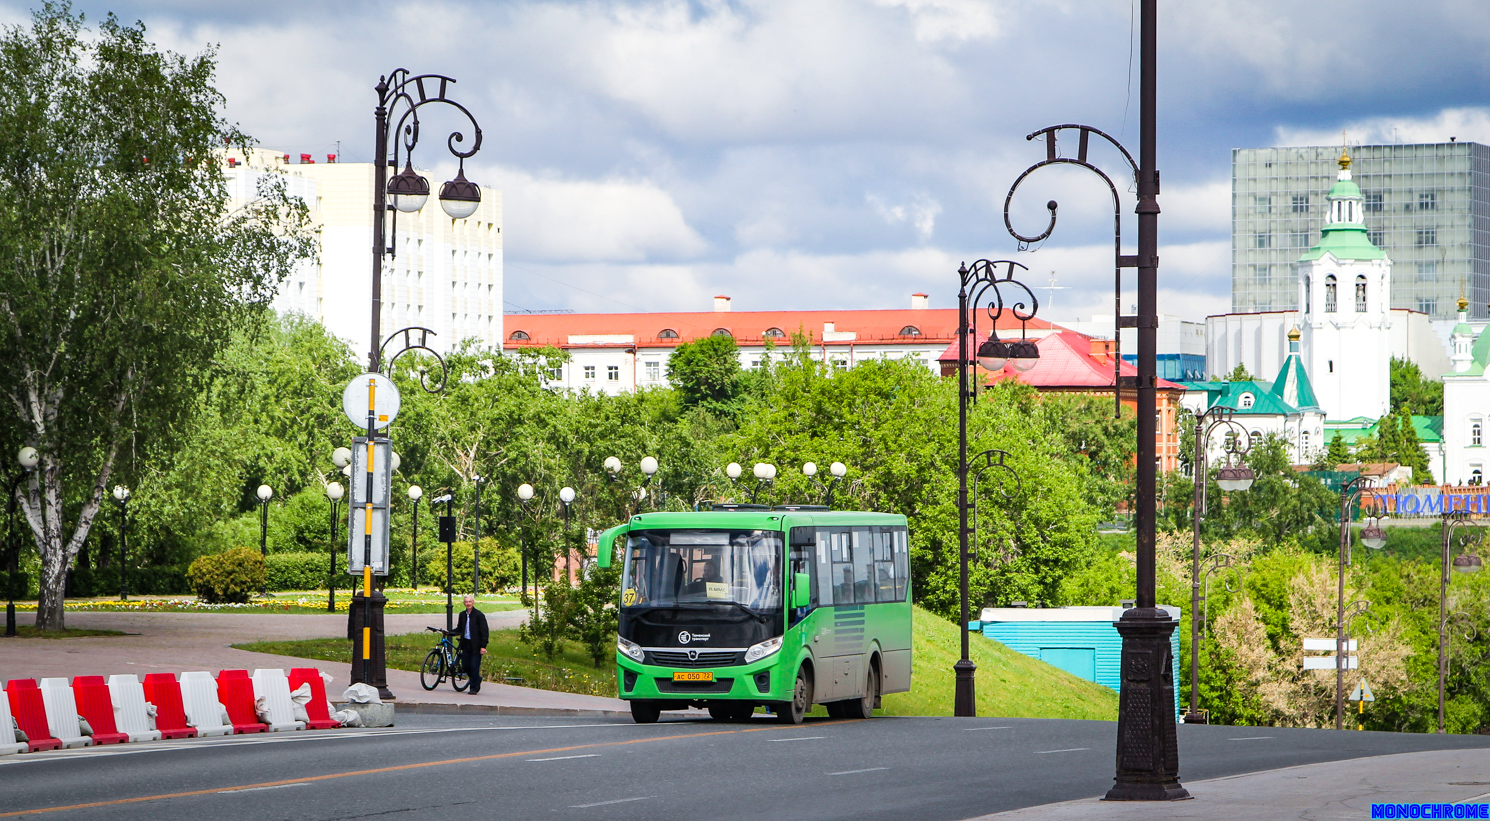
[{"left": 502, "top": 294, "right": 1053, "bottom": 393}]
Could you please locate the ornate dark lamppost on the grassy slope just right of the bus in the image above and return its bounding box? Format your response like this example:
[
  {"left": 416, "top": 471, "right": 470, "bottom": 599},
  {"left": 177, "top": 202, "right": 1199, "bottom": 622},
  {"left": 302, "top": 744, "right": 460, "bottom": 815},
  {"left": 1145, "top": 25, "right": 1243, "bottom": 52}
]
[{"left": 952, "top": 263, "right": 1040, "bottom": 717}]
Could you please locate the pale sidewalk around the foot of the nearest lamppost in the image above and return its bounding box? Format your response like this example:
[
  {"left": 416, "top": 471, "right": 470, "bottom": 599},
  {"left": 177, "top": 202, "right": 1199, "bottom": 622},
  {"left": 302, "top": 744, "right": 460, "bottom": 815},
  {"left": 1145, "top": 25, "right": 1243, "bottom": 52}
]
[{"left": 971, "top": 749, "right": 1490, "bottom": 821}]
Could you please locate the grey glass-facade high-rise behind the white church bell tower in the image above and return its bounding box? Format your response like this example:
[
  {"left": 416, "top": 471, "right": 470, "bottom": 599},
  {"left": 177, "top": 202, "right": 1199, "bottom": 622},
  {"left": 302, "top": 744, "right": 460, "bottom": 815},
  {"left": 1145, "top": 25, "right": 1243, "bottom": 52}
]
[{"left": 1231, "top": 142, "right": 1490, "bottom": 319}]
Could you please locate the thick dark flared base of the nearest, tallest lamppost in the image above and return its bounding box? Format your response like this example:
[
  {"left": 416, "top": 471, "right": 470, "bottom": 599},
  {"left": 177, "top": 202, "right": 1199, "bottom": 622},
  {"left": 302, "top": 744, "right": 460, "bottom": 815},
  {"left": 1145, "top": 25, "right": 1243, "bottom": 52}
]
[{"left": 1104, "top": 608, "right": 1191, "bottom": 802}]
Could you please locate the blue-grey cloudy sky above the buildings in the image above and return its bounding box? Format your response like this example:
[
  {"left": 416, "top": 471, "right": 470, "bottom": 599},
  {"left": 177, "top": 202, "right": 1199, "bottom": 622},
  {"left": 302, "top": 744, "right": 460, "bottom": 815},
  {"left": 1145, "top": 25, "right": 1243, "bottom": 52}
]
[{"left": 11, "top": 0, "right": 1490, "bottom": 320}]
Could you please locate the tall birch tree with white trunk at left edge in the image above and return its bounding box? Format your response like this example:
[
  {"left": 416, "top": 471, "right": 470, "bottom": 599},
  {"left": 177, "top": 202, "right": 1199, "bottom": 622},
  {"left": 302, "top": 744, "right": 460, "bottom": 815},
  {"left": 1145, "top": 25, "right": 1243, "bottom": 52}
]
[{"left": 0, "top": 3, "right": 313, "bottom": 630}]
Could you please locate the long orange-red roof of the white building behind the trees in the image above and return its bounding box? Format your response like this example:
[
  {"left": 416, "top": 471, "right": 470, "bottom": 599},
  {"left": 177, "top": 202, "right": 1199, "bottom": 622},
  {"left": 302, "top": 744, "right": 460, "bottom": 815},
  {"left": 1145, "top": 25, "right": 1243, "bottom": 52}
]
[{"left": 502, "top": 308, "right": 1053, "bottom": 347}]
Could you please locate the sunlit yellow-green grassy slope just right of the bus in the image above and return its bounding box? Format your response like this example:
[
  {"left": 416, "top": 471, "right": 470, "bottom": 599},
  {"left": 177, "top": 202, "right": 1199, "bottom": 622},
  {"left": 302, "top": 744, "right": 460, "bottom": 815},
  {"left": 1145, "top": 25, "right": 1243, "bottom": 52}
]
[{"left": 884, "top": 608, "right": 1118, "bottom": 721}]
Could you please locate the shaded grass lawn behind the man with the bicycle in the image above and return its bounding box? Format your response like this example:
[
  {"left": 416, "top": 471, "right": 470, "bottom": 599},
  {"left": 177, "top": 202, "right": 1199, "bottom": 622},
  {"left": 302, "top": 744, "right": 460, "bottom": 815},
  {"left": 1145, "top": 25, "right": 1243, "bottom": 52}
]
[{"left": 232, "top": 628, "right": 615, "bottom": 697}]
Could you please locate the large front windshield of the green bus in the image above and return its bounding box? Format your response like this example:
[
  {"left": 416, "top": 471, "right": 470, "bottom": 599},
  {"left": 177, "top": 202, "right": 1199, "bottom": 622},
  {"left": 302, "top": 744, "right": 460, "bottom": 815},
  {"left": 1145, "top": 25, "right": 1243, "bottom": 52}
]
[{"left": 621, "top": 530, "right": 782, "bottom": 614}]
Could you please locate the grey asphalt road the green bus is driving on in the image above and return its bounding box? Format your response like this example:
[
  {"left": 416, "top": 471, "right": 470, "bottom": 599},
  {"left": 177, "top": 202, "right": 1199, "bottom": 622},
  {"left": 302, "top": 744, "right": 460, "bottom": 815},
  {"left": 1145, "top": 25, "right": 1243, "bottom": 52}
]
[{"left": 0, "top": 715, "right": 1490, "bottom": 821}]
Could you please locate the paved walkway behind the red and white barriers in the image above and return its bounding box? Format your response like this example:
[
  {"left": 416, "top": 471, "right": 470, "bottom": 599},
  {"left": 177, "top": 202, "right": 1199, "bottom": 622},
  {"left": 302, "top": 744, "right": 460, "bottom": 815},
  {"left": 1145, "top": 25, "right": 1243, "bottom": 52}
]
[{"left": 0, "top": 609, "right": 630, "bottom": 714}]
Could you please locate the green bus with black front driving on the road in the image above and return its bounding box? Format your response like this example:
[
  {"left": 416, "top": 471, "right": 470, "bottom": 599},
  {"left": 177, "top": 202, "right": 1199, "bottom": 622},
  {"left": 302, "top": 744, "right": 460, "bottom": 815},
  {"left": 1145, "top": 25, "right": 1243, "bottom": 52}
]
[{"left": 599, "top": 505, "right": 910, "bottom": 724}]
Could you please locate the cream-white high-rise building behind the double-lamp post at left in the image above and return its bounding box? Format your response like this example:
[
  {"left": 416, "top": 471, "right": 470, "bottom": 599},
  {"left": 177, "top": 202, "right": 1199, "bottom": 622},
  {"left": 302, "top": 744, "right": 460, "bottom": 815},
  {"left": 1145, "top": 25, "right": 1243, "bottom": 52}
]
[{"left": 225, "top": 149, "right": 502, "bottom": 356}]
